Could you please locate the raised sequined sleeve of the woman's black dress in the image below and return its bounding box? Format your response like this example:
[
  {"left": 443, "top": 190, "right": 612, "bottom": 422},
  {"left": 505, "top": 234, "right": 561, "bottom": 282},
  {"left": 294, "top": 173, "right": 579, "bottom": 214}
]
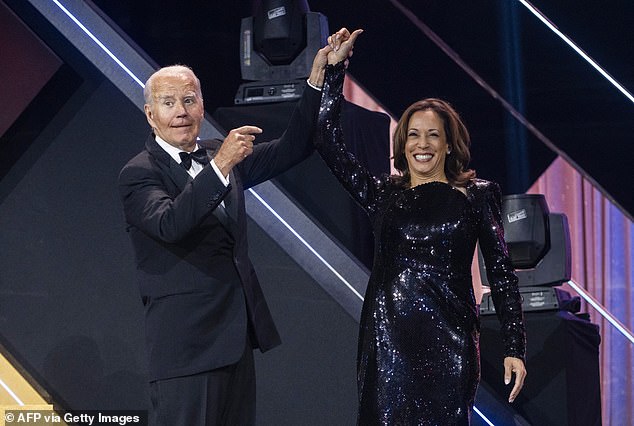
[{"left": 315, "top": 62, "right": 387, "bottom": 213}]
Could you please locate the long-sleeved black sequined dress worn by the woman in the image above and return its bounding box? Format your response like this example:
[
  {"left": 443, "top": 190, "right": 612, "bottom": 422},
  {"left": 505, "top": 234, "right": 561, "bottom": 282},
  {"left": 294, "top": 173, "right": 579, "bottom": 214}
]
[{"left": 316, "top": 64, "right": 525, "bottom": 426}]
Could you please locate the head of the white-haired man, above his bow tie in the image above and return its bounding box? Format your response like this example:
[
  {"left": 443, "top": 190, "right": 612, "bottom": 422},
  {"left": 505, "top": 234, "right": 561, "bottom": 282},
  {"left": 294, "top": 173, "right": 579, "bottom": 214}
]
[{"left": 145, "top": 69, "right": 204, "bottom": 151}]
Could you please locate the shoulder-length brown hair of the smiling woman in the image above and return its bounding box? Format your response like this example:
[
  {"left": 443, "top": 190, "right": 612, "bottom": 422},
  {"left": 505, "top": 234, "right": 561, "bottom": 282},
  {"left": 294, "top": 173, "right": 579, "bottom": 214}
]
[{"left": 393, "top": 98, "right": 475, "bottom": 186}]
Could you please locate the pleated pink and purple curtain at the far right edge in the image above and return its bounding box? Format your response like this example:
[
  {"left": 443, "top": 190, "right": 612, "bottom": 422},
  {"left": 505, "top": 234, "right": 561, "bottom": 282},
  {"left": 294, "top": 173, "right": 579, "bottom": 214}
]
[{"left": 528, "top": 157, "right": 634, "bottom": 425}]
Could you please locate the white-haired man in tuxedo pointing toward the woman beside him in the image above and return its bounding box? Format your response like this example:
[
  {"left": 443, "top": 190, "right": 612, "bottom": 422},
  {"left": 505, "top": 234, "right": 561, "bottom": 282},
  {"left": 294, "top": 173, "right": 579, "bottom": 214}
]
[{"left": 119, "top": 32, "right": 338, "bottom": 426}]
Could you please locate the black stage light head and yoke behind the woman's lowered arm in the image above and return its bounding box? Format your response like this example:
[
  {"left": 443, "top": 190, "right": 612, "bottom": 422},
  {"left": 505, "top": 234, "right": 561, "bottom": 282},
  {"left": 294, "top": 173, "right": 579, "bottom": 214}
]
[{"left": 478, "top": 194, "right": 571, "bottom": 286}]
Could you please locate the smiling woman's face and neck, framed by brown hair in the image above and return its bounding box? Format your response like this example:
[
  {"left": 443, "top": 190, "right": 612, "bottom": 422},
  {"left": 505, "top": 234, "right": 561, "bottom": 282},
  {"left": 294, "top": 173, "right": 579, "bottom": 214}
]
[{"left": 405, "top": 110, "right": 448, "bottom": 187}]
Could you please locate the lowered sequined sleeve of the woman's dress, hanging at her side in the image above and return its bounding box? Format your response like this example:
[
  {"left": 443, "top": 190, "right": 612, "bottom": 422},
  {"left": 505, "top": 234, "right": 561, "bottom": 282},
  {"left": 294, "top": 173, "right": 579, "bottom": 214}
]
[{"left": 478, "top": 183, "right": 526, "bottom": 360}]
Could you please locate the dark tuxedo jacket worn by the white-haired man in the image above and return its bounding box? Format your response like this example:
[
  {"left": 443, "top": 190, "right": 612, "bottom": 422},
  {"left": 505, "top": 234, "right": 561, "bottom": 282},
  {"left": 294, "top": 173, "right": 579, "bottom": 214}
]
[{"left": 119, "top": 87, "right": 320, "bottom": 380}]
